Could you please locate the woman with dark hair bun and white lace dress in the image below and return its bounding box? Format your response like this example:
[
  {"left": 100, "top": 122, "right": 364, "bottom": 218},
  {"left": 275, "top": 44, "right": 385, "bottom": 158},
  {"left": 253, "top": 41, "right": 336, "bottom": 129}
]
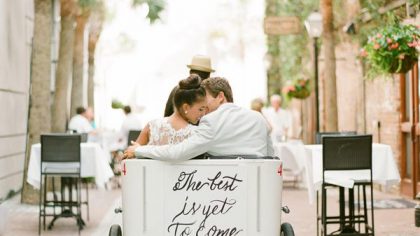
[{"left": 133, "top": 74, "right": 207, "bottom": 145}]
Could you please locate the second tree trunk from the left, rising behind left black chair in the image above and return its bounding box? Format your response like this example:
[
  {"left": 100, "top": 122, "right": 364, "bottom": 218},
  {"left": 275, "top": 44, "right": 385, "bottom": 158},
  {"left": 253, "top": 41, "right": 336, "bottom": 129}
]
[{"left": 52, "top": 0, "right": 76, "bottom": 132}]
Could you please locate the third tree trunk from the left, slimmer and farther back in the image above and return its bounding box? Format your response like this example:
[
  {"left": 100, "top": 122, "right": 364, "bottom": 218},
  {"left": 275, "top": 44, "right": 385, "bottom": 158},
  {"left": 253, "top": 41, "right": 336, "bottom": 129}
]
[{"left": 70, "top": 14, "right": 89, "bottom": 116}]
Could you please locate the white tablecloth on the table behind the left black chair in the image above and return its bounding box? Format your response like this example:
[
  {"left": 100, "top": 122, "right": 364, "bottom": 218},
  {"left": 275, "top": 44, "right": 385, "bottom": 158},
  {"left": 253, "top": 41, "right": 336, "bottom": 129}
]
[{"left": 26, "top": 143, "right": 114, "bottom": 189}]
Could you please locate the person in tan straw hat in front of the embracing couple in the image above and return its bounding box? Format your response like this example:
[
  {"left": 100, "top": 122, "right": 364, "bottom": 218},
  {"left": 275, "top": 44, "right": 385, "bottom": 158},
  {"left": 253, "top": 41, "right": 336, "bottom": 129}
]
[{"left": 164, "top": 55, "right": 214, "bottom": 117}]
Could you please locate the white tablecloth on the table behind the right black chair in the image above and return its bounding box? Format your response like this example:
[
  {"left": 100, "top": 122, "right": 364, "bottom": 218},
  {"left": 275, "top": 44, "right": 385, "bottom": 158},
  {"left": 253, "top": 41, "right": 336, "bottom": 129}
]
[{"left": 305, "top": 143, "right": 401, "bottom": 203}]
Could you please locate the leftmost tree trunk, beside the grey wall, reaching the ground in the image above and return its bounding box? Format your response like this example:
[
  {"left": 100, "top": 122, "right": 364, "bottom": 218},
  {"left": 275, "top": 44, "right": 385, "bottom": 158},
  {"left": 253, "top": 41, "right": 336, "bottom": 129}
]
[{"left": 21, "top": 0, "right": 52, "bottom": 203}]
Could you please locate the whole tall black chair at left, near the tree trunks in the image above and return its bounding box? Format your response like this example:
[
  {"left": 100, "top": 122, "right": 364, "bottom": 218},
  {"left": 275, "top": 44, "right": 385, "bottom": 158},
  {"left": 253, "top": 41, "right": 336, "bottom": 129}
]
[{"left": 38, "top": 134, "right": 84, "bottom": 234}]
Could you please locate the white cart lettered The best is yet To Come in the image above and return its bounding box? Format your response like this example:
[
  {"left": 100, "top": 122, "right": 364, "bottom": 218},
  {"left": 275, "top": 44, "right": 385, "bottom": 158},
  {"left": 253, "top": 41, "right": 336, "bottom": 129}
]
[{"left": 109, "top": 157, "right": 294, "bottom": 236}]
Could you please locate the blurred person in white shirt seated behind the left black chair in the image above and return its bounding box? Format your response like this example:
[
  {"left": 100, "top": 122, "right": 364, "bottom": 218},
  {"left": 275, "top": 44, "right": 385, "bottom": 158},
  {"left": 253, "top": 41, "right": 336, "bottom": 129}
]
[{"left": 68, "top": 107, "right": 96, "bottom": 134}]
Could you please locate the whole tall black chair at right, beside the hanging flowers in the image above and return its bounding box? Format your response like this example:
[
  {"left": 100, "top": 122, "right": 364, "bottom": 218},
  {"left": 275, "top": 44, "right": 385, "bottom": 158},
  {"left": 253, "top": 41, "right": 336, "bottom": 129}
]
[{"left": 317, "top": 135, "right": 375, "bottom": 236}]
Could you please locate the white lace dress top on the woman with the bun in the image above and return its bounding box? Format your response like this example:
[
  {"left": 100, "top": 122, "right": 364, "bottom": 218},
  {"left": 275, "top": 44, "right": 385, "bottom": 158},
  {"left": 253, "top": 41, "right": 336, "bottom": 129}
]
[{"left": 148, "top": 118, "right": 196, "bottom": 145}]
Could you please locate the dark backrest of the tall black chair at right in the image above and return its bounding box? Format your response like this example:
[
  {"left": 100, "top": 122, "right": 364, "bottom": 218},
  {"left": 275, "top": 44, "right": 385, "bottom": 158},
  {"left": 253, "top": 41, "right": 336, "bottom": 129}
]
[{"left": 322, "top": 135, "right": 372, "bottom": 171}]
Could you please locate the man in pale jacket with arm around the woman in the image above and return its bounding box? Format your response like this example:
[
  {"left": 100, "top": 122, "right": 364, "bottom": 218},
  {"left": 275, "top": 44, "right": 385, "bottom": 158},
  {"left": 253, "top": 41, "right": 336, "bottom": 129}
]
[{"left": 124, "top": 77, "right": 273, "bottom": 161}]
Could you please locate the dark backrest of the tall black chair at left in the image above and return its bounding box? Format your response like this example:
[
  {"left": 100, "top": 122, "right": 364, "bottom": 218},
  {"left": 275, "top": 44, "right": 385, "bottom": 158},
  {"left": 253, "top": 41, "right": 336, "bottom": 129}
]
[{"left": 41, "top": 134, "right": 81, "bottom": 162}]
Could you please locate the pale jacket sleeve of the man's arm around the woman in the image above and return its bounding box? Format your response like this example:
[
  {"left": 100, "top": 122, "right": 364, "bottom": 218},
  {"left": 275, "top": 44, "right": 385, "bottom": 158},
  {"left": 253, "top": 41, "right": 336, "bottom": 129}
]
[{"left": 135, "top": 118, "right": 214, "bottom": 161}]
